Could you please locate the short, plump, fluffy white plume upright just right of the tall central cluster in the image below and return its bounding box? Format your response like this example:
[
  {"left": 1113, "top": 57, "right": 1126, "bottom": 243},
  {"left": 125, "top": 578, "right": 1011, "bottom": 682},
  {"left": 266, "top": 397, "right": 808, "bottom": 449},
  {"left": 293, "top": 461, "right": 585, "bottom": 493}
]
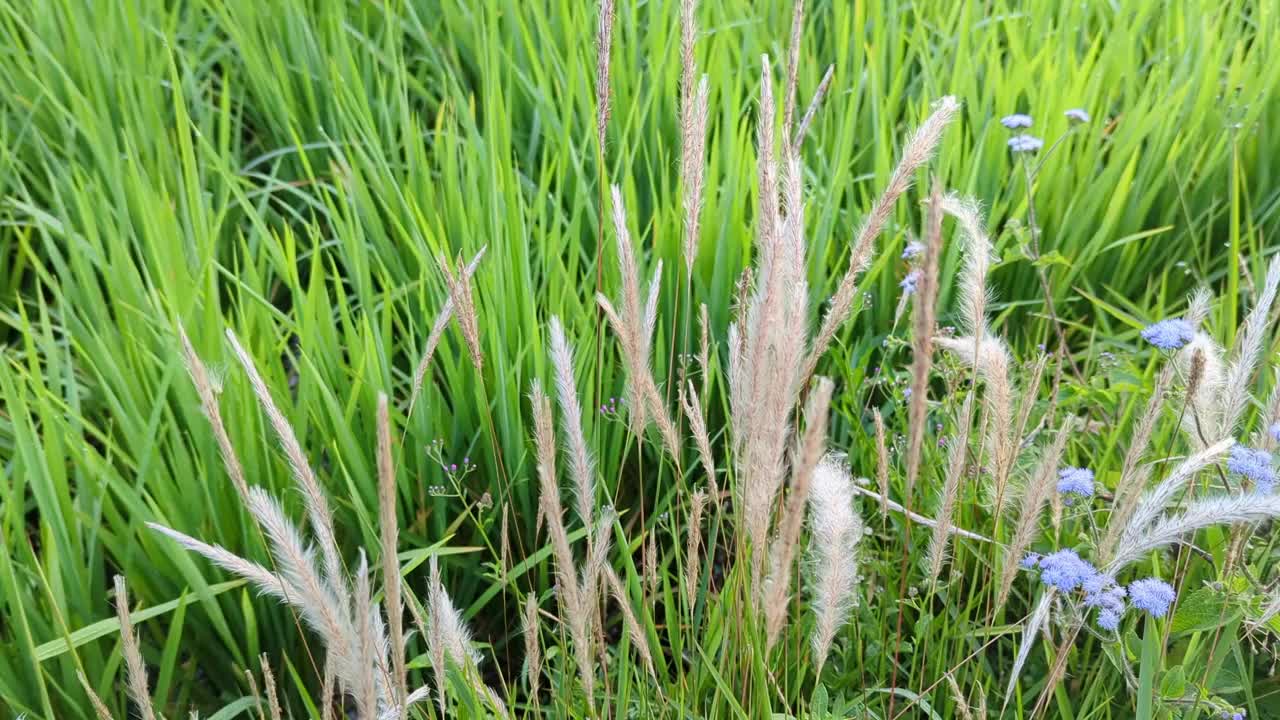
[{"left": 809, "top": 456, "right": 863, "bottom": 675}]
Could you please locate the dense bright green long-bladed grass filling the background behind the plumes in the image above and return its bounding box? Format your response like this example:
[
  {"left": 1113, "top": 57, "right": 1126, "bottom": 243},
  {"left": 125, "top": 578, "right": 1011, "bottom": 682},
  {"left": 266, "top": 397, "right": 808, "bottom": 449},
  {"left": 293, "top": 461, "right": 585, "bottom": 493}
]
[{"left": 0, "top": 0, "right": 1280, "bottom": 719}]
